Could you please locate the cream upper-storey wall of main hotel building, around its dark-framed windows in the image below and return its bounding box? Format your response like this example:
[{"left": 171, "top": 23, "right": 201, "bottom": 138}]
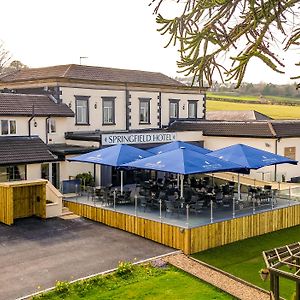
[{"left": 61, "top": 87, "right": 204, "bottom": 131}]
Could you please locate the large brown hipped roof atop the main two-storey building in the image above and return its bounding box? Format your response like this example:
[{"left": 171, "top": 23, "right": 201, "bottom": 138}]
[{"left": 0, "top": 64, "right": 185, "bottom": 87}]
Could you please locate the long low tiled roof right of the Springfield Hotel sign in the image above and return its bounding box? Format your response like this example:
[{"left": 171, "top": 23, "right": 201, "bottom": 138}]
[{"left": 168, "top": 120, "right": 300, "bottom": 138}]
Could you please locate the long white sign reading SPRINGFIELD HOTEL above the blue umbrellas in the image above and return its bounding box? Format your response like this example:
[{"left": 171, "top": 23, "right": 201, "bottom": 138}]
[{"left": 102, "top": 132, "right": 176, "bottom": 145}]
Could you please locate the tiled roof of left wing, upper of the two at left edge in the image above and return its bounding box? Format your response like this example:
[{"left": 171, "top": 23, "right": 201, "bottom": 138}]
[{"left": 0, "top": 93, "right": 74, "bottom": 117}]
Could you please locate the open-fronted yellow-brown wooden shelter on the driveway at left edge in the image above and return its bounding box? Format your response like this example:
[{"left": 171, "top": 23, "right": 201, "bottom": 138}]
[{"left": 0, "top": 179, "right": 47, "bottom": 225}]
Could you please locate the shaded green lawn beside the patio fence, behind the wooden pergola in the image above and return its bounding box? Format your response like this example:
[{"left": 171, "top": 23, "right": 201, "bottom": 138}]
[{"left": 193, "top": 226, "right": 300, "bottom": 299}]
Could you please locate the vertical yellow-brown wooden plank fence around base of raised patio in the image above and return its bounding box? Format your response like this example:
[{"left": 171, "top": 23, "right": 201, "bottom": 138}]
[{"left": 64, "top": 201, "right": 300, "bottom": 254}]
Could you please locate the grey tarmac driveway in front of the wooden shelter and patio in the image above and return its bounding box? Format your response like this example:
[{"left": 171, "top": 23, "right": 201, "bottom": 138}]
[{"left": 0, "top": 218, "right": 173, "bottom": 300}]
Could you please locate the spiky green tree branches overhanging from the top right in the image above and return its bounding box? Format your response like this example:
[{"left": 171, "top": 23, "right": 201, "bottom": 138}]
[{"left": 150, "top": 0, "right": 300, "bottom": 87}]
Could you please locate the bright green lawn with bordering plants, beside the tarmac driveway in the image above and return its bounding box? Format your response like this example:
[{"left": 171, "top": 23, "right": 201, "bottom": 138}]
[{"left": 34, "top": 265, "right": 233, "bottom": 300}]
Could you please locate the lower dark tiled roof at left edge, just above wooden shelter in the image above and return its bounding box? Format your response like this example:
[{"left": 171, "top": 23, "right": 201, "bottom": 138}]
[{"left": 0, "top": 136, "right": 56, "bottom": 165}]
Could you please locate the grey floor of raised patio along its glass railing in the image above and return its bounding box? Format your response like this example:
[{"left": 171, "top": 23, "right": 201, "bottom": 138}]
[{"left": 64, "top": 187, "right": 300, "bottom": 228}]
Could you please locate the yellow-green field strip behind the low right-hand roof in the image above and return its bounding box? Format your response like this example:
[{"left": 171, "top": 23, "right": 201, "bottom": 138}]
[{"left": 207, "top": 100, "right": 300, "bottom": 119}]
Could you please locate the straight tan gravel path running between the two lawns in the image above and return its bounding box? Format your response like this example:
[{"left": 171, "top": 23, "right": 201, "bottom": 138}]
[{"left": 164, "top": 254, "right": 270, "bottom": 300}]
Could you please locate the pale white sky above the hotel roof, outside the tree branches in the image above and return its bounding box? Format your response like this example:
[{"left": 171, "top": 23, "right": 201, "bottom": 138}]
[{"left": 0, "top": 0, "right": 299, "bottom": 84}]
